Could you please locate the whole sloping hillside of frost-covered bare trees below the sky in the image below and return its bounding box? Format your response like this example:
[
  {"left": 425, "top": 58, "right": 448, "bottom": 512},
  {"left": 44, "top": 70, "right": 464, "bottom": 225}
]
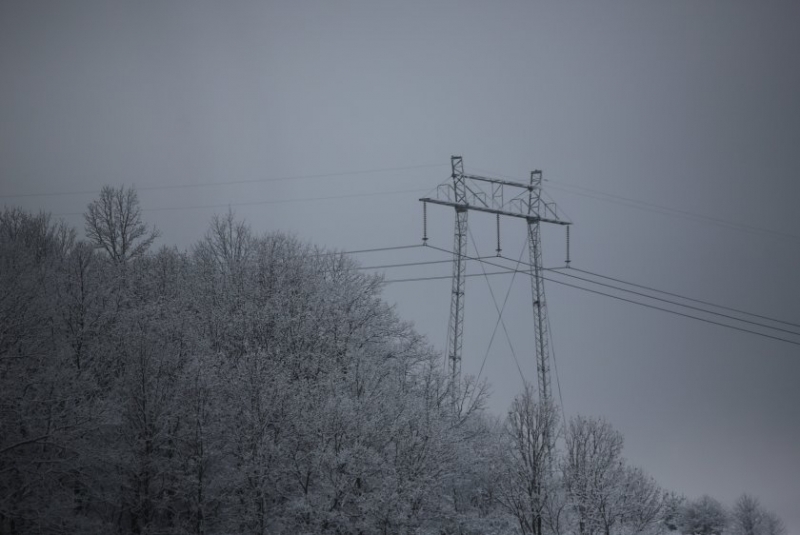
[{"left": 0, "top": 188, "right": 786, "bottom": 535}]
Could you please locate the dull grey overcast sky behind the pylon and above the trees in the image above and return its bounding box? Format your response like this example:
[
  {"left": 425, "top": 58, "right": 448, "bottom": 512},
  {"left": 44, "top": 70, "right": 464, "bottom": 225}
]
[{"left": 0, "top": 0, "right": 800, "bottom": 535}]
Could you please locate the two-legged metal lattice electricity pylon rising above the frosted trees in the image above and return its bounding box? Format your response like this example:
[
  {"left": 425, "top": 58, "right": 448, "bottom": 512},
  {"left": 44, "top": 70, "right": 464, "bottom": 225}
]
[{"left": 420, "top": 156, "right": 572, "bottom": 403}]
